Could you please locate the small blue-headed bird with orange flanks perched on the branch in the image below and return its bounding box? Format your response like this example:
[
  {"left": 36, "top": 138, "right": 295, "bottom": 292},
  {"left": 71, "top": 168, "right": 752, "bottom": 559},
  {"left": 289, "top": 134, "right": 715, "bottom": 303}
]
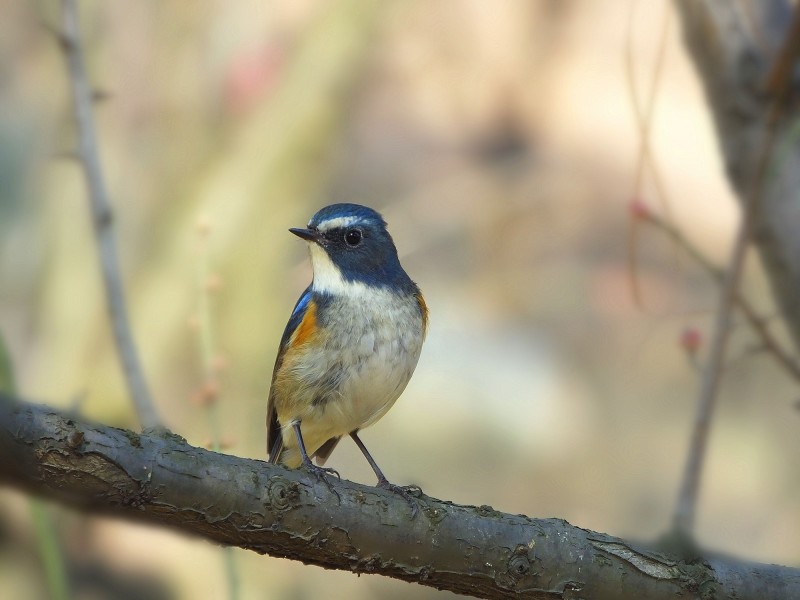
[{"left": 267, "top": 204, "right": 428, "bottom": 495}]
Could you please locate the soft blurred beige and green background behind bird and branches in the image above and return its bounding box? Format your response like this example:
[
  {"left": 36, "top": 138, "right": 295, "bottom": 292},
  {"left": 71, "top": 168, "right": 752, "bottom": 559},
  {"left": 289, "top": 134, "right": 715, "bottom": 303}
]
[{"left": 0, "top": 0, "right": 800, "bottom": 599}]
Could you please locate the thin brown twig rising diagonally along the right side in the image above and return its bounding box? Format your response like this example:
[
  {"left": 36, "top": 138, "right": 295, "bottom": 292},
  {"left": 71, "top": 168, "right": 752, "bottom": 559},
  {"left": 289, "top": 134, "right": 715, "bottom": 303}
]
[{"left": 673, "top": 3, "right": 800, "bottom": 537}]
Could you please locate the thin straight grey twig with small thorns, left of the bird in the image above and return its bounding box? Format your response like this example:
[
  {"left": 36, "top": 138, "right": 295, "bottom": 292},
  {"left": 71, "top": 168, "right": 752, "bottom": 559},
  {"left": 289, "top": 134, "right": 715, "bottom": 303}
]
[{"left": 59, "top": 0, "right": 159, "bottom": 428}]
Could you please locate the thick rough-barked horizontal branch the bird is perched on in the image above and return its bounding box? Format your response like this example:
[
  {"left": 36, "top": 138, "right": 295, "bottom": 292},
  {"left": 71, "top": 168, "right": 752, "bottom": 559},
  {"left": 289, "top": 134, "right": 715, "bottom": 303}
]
[{"left": 0, "top": 399, "right": 800, "bottom": 600}]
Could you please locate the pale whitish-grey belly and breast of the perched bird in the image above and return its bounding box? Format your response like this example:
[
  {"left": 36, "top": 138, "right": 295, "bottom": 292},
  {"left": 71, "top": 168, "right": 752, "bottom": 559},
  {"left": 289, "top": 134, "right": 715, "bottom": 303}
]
[{"left": 275, "top": 292, "right": 424, "bottom": 467}]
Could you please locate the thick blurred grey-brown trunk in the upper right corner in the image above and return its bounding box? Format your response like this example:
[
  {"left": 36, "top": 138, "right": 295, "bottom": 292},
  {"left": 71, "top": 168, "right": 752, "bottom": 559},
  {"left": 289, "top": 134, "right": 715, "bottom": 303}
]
[{"left": 675, "top": 0, "right": 800, "bottom": 348}]
